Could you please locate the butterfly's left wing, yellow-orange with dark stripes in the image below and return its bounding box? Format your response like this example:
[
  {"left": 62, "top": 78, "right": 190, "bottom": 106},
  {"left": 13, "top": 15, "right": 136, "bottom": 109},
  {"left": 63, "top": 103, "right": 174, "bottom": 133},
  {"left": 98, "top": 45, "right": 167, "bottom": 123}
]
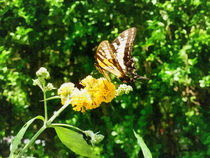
[{"left": 95, "top": 41, "right": 125, "bottom": 80}]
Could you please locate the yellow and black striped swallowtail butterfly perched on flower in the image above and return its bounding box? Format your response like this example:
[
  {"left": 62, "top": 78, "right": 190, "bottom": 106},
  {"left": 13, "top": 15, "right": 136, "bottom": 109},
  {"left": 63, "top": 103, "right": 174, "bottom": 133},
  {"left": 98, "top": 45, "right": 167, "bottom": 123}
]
[{"left": 95, "top": 27, "right": 147, "bottom": 83}]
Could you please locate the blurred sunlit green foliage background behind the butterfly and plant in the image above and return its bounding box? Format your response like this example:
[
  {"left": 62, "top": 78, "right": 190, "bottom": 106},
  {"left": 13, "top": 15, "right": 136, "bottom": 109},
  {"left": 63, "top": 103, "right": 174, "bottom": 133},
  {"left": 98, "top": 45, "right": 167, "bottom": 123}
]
[{"left": 0, "top": 0, "right": 210, "bottom": 158}]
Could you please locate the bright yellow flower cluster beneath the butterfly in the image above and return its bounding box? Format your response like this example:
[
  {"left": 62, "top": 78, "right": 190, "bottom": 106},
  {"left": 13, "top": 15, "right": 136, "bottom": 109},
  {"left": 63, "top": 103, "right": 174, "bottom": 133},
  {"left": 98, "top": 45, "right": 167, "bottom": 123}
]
[{"left": 58, "top": 76, "right": 116, "bottom": 112}]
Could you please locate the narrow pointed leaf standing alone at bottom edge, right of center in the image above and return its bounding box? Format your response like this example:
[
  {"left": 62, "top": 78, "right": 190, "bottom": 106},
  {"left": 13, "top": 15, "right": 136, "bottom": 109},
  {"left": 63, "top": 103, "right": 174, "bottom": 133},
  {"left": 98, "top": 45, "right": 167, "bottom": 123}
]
[{"left": 133, "top": 131, "right": 152, "bottom": 158}]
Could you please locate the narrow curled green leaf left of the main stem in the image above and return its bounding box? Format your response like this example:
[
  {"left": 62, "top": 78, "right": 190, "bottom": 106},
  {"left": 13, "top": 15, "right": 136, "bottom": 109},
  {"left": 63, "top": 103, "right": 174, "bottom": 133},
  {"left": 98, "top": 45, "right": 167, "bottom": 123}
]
[{"left": 9, "top": 116, "right": 44, "bottom": 157}]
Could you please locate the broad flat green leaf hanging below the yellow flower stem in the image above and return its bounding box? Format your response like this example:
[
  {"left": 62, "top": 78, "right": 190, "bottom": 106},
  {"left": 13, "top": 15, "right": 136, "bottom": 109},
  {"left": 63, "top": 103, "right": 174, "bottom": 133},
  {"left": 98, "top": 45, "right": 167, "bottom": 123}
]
[{"left": 54, "top": 127, "right": 96, "bottom": 157}]
